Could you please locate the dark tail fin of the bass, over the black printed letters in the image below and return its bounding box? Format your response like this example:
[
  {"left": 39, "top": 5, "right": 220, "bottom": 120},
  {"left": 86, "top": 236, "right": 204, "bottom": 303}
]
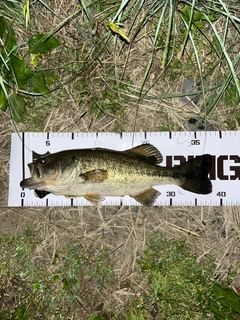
[{"left": 179, "top": 154, "right": 212, "bottom": 194}]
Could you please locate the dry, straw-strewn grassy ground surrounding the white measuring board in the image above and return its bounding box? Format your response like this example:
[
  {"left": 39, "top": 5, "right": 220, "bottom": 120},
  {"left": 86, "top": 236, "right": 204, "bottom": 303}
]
[{"left": 0, "top": 1, "right": 240, "bottom": 319}]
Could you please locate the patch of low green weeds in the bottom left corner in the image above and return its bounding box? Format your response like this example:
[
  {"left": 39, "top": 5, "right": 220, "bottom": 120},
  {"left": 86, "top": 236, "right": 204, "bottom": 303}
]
[{"left": 0, "top": 228, "right": 114, "bottom": 320}]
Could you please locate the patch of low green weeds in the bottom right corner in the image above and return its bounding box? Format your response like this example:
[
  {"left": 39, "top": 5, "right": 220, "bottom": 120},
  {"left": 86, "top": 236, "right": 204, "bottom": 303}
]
[{"left": 126, "top": 235, "right": 240, "bottom": 320}]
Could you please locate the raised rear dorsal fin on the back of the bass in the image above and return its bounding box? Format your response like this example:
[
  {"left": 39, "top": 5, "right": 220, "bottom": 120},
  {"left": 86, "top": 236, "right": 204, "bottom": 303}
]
[{"left": 125, "top": 143, "right": 163, "bottom": 164}]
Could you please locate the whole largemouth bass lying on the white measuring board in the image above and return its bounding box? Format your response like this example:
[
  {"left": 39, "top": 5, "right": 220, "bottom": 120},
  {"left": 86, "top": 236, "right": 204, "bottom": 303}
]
[{"left": 20, "top": 144, "right": 212, "bottom": 207}]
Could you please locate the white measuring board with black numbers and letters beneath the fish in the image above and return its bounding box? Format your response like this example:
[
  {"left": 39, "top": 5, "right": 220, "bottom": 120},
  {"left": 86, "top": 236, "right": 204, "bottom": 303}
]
[{"left": 8, "top": 131, "right": 240, "bottom": 206}]
